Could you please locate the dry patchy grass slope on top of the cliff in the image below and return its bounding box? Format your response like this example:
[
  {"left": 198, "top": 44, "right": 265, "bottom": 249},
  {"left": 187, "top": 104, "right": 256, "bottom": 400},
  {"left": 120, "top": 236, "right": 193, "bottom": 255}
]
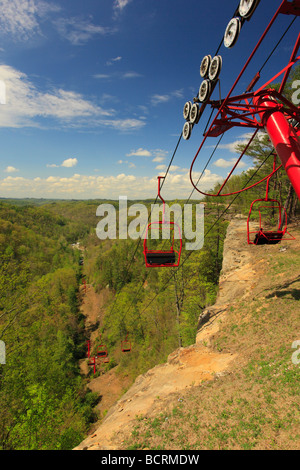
[{"left": 124, "top": 229, "right": 300, "bottom": 450}]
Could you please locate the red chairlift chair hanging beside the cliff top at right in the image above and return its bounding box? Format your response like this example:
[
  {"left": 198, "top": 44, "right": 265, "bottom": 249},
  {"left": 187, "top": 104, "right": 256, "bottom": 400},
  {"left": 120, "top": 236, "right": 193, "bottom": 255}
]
[{"left": 247, "top": 157, "right": 295, "bottom": 245}]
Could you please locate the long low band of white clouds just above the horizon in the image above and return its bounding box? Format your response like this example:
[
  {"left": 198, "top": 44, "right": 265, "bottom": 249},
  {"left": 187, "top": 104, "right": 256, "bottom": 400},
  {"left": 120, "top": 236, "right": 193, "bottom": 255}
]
[{"left": 0, "top": 170, "right": 222, "bottom": 200}]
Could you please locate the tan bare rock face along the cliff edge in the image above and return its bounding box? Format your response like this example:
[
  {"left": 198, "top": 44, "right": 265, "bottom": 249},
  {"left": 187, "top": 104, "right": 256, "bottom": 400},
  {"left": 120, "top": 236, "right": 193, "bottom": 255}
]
[{"left": 74, "top": 218, "right": 255, "bottom": 450}]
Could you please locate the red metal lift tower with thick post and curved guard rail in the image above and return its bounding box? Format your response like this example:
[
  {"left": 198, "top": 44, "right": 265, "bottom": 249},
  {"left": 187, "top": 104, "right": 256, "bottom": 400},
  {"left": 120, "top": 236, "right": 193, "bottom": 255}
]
[{"left": 190, "top": 0, "right": 300, "bottom": 199}]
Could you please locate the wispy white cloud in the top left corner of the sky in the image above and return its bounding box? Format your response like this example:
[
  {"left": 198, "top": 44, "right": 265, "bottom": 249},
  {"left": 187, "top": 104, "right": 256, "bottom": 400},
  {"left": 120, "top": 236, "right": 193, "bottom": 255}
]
[{"left": 0, "top": 0, "right": 61, "bottom": 41}]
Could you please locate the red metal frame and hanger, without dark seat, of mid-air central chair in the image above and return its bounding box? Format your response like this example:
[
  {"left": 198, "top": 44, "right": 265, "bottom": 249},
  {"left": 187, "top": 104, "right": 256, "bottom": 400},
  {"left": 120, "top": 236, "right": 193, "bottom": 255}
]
[{"left": 144, "top": 176, "right": 182, "bottom": 268}]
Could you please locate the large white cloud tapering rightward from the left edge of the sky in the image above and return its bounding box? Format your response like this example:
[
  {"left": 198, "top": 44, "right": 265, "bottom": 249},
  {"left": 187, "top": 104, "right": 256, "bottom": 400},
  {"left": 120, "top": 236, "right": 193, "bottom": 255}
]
[{"left": 0, "top": 65, "right": 145, "bottom": 131}]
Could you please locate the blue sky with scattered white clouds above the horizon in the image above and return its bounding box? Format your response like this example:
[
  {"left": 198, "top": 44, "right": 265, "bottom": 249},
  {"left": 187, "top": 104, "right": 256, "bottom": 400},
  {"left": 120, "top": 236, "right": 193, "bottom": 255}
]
[{"left": 0, "top": 0, "right": 299, "bottom": 199}]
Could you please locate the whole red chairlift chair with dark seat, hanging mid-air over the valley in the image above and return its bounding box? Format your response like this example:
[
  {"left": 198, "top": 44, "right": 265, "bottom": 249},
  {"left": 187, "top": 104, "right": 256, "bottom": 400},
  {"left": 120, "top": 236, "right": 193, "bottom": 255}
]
[{"left": 144, "top": 176, "right": 182, "bottom": 268}]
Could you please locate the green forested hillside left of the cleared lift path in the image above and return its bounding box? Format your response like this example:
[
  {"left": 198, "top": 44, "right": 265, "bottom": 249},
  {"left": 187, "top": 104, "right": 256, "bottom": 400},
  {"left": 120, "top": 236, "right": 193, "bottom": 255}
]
[{"left": 0, "top": 203, "right": 93, "bottom": 449}]
